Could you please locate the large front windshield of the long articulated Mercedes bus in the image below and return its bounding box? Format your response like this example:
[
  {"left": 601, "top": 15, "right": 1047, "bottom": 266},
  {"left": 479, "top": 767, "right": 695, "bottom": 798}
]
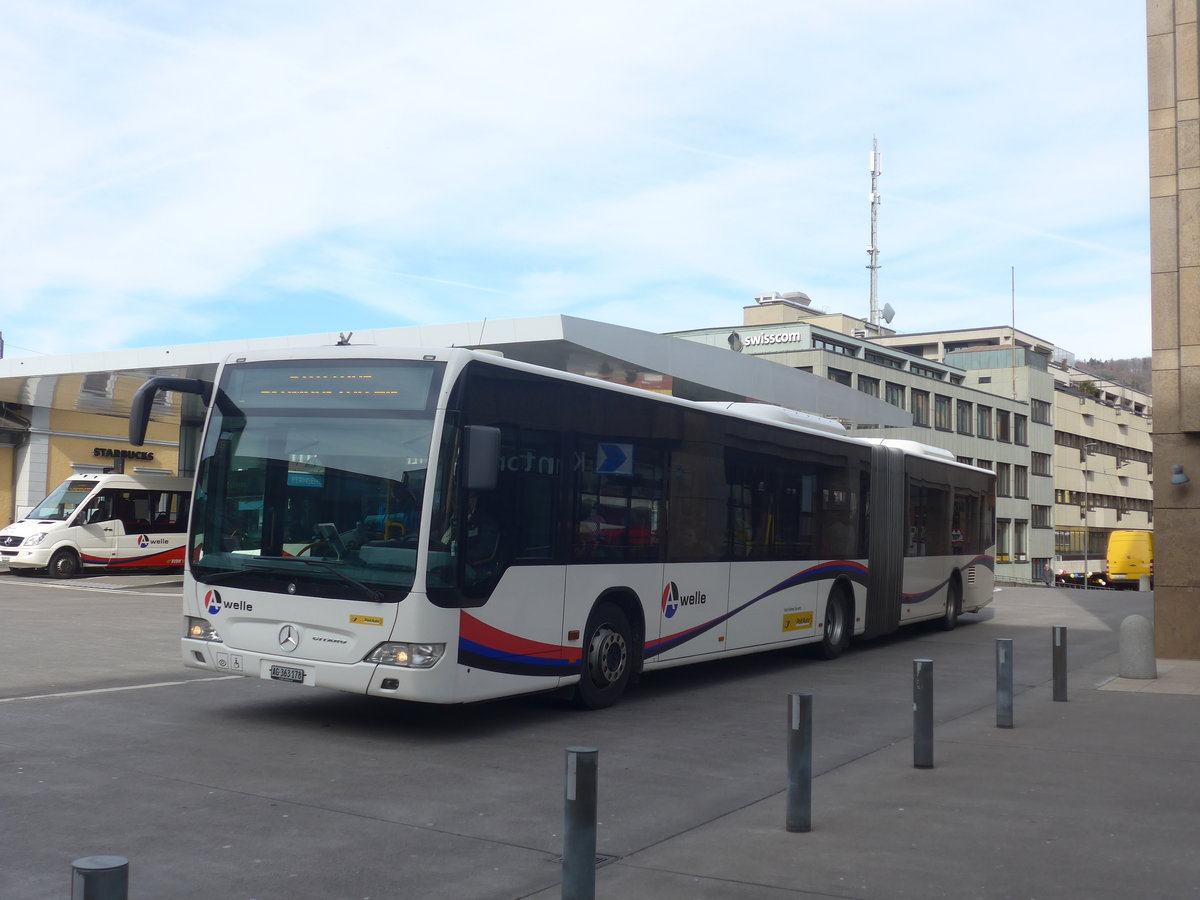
[{"left": 191, "top": 360, "right": 442, "bottom": 600}]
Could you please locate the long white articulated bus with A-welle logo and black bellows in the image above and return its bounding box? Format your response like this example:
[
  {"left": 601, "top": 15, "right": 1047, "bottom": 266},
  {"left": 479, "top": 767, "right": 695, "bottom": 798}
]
[{"left": 130, "top": 347, "right": 995, "bottom": 708}]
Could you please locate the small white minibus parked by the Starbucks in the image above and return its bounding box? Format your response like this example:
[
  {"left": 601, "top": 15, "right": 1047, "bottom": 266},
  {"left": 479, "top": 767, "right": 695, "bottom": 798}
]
[{"left": 0, "top": 474, "right": 192, "bottom": 578}]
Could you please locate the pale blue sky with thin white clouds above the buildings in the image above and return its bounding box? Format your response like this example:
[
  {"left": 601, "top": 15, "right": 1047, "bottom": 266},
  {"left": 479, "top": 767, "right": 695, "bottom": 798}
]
[{"left": 0, "top": 0, "right": 1151, "bottom": 360}]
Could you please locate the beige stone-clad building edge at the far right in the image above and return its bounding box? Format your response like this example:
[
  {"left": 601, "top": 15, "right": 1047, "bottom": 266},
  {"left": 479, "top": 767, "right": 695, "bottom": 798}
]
[{"left": 1146, "top": 0, "right": 1200, "bottom": 659}]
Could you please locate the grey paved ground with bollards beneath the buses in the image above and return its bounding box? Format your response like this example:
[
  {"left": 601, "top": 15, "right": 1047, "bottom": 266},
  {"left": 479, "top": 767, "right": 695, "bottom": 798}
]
[{"left": 0, "top": 575, "right": 1200, "bottom": 900}]
